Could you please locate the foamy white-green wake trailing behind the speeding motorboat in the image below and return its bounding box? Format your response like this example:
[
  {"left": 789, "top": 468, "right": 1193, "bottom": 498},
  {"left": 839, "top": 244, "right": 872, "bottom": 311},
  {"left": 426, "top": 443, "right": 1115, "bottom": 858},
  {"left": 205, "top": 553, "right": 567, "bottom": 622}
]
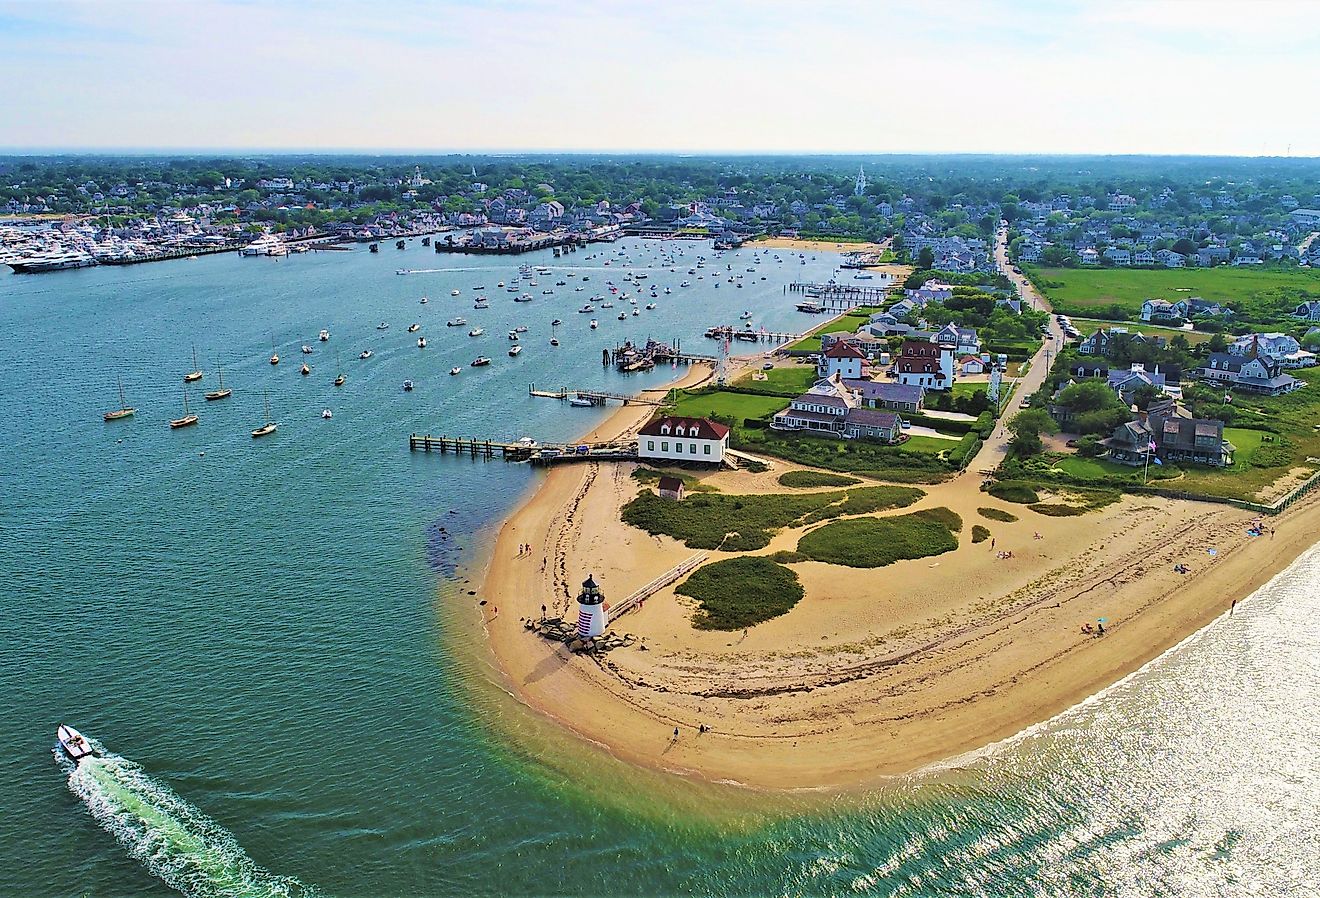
[{"left": 61, "top": 742, "right": 318, "bottom": 898}]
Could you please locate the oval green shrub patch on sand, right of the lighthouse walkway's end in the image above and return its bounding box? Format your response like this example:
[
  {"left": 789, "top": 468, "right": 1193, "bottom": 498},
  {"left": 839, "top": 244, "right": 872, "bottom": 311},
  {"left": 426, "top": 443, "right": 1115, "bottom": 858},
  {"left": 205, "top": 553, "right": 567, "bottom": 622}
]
[{"left": 797, "top": 510, "right": 961, "bottom": 568}]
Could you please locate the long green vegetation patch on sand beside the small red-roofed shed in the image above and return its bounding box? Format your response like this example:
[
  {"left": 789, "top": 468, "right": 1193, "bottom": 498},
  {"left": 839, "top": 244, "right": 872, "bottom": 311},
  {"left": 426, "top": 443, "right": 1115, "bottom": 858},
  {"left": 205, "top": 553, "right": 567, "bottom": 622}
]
[{"left": 622, "top": 486, "right": 925, "bottom": 552}]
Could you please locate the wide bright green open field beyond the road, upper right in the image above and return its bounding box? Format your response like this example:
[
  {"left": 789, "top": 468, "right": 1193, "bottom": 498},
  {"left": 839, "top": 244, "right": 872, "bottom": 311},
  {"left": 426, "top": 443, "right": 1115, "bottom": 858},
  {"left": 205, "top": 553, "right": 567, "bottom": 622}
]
[{"left": 1031, "top": 267, "right": 1320, "bottom": 320}]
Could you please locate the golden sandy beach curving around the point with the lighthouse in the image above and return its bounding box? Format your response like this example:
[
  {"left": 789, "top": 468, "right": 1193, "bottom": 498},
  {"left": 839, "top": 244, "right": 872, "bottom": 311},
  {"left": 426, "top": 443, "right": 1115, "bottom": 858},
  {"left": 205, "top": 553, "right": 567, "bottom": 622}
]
[{"left": 479, "top": 361, "right": 1320, "bottom": 790}]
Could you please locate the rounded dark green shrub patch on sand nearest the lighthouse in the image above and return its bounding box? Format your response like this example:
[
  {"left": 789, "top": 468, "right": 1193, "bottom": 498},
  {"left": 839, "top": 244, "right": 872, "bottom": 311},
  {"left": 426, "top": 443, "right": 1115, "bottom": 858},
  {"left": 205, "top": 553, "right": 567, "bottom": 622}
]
[{"left": 675, "top": 556, "right": 803, "bottom": 630}]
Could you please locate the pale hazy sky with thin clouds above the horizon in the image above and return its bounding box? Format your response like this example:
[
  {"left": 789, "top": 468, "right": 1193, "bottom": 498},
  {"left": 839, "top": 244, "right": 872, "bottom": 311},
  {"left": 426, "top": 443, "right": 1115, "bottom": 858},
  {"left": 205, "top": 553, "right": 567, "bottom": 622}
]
[{"left": 0, "top": 0, "right": 1320, "bottom": 156}]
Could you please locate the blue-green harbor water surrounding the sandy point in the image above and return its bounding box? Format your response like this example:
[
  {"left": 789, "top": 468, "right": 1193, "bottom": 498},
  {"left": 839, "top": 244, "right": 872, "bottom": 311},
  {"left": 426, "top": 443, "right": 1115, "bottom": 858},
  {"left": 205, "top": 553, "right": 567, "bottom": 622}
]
[{"left": 0, "top": 242, "right": 1320, "bottom": 895}]
